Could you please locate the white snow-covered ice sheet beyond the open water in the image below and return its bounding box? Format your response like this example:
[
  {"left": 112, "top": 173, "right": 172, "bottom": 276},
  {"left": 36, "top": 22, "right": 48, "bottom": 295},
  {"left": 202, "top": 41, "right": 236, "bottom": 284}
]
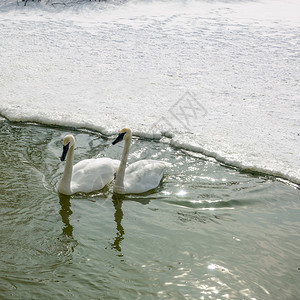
[{"left": 0, "top": 0, "right": 300, "bottom": 184}]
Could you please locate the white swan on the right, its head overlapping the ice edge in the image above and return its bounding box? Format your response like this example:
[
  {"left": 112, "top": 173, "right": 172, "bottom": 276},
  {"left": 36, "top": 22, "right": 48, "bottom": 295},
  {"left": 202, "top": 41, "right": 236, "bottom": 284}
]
[{"left": 112, "top": 128, "right": 171, "bottom": 194}]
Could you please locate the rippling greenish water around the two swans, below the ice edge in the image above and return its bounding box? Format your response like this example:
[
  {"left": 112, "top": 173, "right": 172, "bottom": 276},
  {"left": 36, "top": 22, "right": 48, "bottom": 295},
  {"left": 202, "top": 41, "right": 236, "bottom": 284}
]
[{"left": 0, "top": 120, "right": 300, "bottom": 299}]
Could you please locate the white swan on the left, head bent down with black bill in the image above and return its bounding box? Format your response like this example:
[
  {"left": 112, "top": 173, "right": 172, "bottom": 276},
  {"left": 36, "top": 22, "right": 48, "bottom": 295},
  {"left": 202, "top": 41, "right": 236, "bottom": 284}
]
[{"left": 58, "top": 134, "right": 120, "bottom": 195}]
